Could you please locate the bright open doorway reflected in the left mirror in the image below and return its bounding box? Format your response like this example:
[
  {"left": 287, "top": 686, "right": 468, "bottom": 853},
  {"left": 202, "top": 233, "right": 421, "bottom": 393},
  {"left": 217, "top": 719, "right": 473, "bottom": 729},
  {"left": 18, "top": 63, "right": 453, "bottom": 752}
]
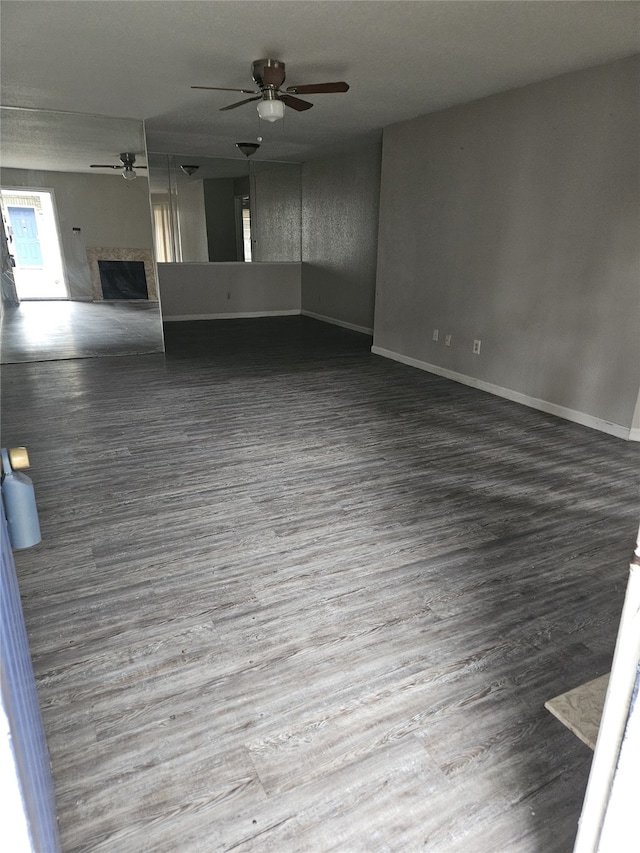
[{"left": 0, "top": 187, "right": 69, "bottom": 300}]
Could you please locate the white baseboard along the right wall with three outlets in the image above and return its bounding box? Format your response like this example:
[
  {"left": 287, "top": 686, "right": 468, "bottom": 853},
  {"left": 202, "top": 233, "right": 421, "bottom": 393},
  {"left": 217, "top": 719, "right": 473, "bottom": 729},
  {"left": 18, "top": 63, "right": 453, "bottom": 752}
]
[{"left": 371, "top": 346, "right": 640, "bottom": 441}]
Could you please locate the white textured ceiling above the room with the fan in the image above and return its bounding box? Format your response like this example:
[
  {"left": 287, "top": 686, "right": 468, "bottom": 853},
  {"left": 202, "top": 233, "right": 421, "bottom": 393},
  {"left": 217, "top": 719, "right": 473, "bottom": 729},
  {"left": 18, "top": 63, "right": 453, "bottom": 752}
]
[{"left": 0, "top": 0, "right": 640, "bottom": 162}]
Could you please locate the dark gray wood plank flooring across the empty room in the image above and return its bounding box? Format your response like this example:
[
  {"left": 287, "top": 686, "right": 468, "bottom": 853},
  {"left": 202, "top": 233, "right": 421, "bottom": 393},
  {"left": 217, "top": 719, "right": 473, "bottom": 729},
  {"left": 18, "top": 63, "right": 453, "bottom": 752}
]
[{"left": 2, "top": 317, "right": 640, "bottom": 853}]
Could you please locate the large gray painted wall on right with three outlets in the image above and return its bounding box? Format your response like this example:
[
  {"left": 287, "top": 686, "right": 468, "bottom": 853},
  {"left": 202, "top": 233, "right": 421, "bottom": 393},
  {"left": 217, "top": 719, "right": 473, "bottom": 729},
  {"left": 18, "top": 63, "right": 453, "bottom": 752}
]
[{"left": 372, "top": 57, "right": 640, "bottom": 427}]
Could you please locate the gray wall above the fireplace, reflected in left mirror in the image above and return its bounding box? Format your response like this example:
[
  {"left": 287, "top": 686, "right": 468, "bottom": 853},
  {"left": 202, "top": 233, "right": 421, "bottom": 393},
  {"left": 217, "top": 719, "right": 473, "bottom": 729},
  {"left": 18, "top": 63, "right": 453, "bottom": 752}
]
[{"left": 1, "top": 169, "right": 153, "bottom": 301}]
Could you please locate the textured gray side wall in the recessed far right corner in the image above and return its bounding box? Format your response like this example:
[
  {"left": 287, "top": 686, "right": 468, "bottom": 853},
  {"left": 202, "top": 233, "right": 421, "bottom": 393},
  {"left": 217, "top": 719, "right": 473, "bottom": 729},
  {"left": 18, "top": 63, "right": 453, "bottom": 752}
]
[{"left": 302, "top": 145, "right": 381, "bottom": 329}]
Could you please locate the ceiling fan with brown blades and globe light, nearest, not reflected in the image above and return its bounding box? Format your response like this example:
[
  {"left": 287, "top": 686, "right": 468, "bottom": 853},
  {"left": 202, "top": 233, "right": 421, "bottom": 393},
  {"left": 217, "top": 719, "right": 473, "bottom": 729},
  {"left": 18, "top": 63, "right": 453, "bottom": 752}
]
[{"left": 191, "top": 59, "right": 349, "bottom": 121}]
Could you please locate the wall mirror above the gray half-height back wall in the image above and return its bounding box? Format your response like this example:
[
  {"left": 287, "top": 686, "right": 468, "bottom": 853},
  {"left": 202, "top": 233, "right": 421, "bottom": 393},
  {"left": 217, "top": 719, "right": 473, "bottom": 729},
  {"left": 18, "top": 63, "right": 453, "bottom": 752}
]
[{"left": 149, "top": 152, "right": 301, "bottom": 263}]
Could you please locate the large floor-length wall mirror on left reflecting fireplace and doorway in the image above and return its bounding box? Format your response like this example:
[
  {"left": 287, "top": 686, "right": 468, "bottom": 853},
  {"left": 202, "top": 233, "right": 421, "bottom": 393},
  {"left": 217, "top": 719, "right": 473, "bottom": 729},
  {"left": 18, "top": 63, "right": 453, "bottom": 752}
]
[{"left": 0, "top": 107, "right": 164, "bottom": 363}]
